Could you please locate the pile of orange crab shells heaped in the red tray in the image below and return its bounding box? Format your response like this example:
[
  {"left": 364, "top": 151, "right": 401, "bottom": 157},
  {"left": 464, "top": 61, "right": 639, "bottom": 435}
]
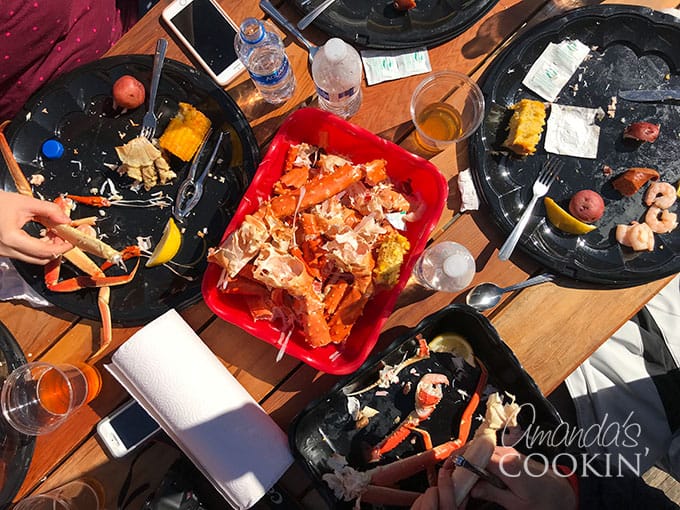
[{"left": 208, "top": 143, "right": 413, "bottom": 347}]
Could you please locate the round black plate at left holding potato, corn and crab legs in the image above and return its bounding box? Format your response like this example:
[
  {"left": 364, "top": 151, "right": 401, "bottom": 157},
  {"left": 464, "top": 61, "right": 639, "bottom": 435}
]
[{"left": 0, "top": 55, "right": 260, "bottom": 326}]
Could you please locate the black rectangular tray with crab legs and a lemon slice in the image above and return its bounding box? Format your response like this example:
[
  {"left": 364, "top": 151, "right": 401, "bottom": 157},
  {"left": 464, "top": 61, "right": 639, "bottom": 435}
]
[{"left": 289, "top": 304, "right": 562, "bottom": 508}]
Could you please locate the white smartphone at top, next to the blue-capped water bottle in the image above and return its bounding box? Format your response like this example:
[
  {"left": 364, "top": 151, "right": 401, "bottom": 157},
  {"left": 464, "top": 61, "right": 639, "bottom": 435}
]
[{"left": 162, "top": 0, "right": 245, "bottom": 86}]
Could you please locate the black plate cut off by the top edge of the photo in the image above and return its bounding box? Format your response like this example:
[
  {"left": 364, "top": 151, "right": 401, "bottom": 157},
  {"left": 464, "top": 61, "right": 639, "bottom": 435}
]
[{"left": 294, "top": 0, "right": 498, "bottom": 49}]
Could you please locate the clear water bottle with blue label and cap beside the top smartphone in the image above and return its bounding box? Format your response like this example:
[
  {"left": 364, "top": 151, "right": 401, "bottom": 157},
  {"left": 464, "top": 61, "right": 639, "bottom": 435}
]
[{"left": 234, "top": 18, "right": 295, "bottom": 104}]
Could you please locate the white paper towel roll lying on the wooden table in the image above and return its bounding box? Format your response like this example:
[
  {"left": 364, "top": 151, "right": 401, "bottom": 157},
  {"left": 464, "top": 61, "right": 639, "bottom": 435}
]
[{"left": 106, "top": 310, "right": 293, "bottom": 510}]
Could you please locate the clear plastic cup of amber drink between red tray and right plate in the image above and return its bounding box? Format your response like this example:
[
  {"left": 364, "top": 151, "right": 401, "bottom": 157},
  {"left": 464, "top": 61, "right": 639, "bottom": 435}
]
[{"left": 411, "top": 71, "right": 484, "bottom": 152}]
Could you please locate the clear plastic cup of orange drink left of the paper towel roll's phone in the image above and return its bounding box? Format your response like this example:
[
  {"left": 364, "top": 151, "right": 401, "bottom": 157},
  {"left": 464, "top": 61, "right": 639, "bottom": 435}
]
[{"left": 0, "top": 361, "right": 101, "bottom": 436}]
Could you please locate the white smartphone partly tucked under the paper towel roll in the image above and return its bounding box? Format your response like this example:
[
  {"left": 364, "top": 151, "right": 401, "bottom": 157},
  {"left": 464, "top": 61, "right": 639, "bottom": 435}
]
[{"left": 97, "top": 399, "right": 161, "bottom": 458}]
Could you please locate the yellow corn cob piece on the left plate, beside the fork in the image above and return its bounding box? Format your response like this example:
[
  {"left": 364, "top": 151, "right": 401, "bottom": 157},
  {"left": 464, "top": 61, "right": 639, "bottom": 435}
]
[{"left": 158, "top": 103, "right": 210, "bottom": 161}]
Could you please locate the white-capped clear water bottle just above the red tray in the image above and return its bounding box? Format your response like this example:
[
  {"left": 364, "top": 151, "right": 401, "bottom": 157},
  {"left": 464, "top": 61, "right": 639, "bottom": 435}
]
[{"left": 312, "top": 37, "right": 362, "bottom": 119}]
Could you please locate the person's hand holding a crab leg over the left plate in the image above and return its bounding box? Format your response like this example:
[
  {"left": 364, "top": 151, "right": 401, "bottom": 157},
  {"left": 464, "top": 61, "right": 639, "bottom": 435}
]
[{"left": 0, "top": 191, "right": 72, "bottom": 265}]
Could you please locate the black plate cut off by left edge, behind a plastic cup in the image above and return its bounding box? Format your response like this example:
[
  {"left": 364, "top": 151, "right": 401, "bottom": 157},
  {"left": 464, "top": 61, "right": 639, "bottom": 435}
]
[{"left": 0, "top": 322, "right": 35, "bottom": 509}]
